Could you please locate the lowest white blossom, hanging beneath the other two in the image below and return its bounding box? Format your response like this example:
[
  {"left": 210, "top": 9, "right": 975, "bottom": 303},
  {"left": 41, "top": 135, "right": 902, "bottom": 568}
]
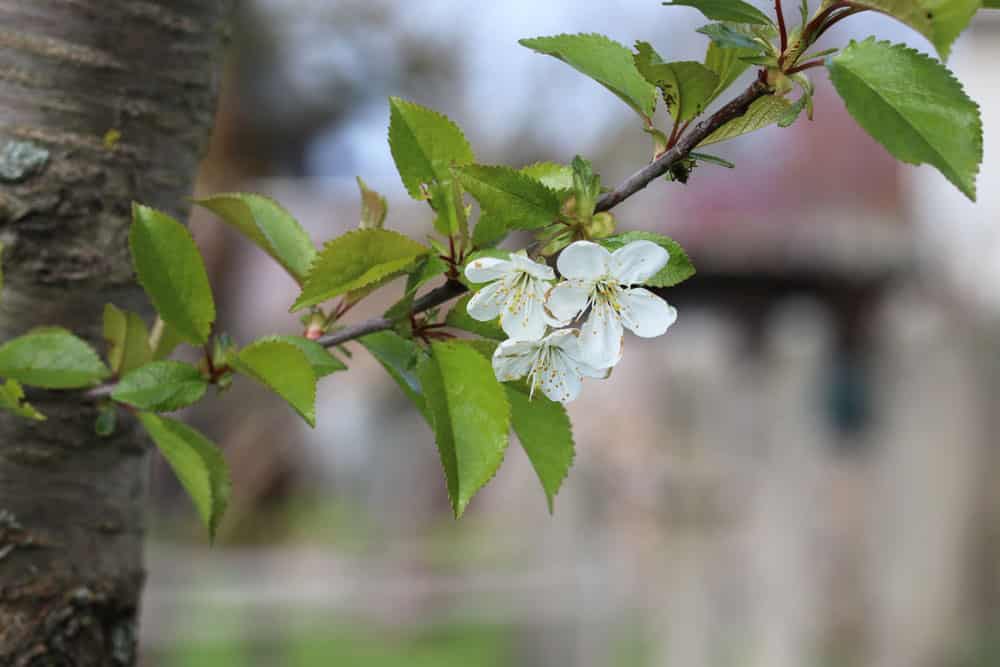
[{"left": 493, "top": 329, "right": 609, "bottom": 403}]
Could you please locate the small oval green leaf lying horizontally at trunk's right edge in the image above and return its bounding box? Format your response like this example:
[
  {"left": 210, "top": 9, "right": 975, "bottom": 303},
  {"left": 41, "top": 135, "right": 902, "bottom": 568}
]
[{"left": 111, "top": 361, "right": 208, "bottom": 412}]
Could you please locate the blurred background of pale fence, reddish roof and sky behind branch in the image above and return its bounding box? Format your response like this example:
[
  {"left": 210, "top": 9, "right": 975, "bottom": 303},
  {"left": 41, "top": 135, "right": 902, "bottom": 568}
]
[{"left": 141, "top": 5, "right": 1000, "bottom": 667}]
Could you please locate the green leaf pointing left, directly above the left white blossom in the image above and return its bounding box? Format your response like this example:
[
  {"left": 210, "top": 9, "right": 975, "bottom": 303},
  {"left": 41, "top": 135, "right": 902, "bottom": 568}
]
[{"left": 457, "top": 165, "right": 560, "bottom": 229}]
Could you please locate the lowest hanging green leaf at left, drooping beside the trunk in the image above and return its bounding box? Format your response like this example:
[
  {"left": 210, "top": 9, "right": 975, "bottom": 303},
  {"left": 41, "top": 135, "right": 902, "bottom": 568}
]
[{"left": 139, "top": 412, "right": 232, "bottom": 539}]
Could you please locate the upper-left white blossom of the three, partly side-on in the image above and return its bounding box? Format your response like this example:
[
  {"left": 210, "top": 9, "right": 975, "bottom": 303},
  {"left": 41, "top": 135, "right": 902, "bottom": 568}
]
[{"left": 465, "top": 252, "right": 556, "bottom": 340}]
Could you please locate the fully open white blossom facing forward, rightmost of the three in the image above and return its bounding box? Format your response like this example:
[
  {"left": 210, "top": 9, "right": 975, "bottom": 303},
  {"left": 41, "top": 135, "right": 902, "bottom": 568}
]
[{"left": 546, "top": 241, "right": 677, "bottom": 368}]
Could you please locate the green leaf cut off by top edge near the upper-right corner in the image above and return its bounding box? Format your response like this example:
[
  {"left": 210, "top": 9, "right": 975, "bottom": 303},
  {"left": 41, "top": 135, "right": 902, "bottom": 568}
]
[{"left": 855, "top": 0, "right": 983, "bottom": 60}]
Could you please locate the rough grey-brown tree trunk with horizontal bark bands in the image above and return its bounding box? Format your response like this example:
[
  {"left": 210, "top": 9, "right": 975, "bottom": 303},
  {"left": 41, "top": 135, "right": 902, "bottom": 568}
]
[{"left": 0, "top": 0, "right": 230, "bottom": 667}]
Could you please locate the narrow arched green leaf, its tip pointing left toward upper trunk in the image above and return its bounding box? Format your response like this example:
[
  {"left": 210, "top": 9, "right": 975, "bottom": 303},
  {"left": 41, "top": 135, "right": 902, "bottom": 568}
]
[{"left": 194, "top": 192, "right": 316, "bottom": 284}]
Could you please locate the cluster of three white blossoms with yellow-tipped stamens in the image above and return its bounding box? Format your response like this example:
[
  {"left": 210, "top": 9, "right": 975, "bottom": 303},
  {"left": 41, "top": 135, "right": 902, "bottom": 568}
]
[{"left": 465, "top": 241, "right": 677, "bottom": 403}]
